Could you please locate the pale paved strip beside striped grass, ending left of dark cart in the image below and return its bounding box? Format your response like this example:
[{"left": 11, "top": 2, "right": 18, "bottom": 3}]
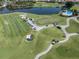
[{"left": 20, "top": 15, "right": 54, "bottom": 31}]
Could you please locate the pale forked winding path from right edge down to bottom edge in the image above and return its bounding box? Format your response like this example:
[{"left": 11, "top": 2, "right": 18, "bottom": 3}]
[{"left": 34, "top": 17, "right": 79, "bottom": 59}]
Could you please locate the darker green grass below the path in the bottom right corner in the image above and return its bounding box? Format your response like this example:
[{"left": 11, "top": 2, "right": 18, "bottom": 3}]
[{"left": 41, "top": 36, "right": 79, "bottom": 59}]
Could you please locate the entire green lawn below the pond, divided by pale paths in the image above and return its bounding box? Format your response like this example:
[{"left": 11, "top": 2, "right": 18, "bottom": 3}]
[{"left": 0, "top": 12, "right": 79, "bottom": 59}]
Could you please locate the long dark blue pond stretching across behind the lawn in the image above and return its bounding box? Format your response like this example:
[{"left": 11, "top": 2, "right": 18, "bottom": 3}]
[{"left": 0, "top": 7, "right": 61, "bottom": 15}]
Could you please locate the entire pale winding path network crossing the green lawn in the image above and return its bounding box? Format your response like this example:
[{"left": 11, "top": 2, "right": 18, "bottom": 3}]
[{"left": 22, "top": 16, "right": 79, "bottom": 59}]
